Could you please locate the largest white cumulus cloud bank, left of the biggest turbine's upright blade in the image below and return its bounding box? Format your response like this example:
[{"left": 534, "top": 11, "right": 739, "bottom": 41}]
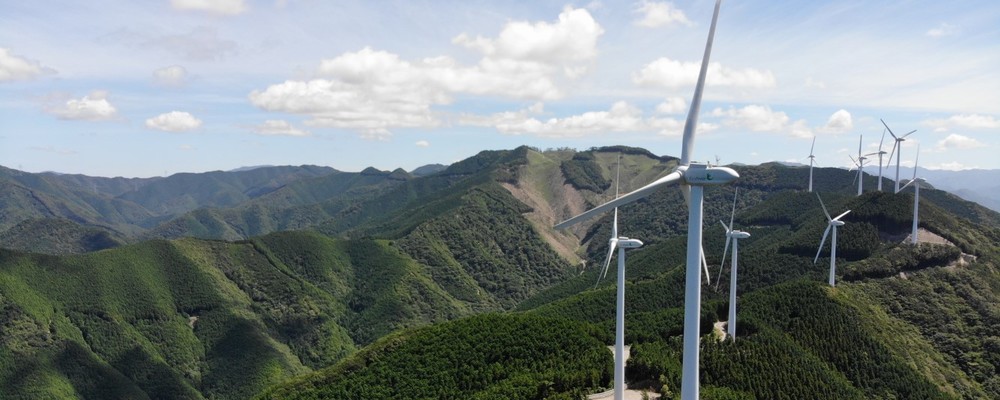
[{"left": 249, "top": 7, "right": 604, "bottom": 140}]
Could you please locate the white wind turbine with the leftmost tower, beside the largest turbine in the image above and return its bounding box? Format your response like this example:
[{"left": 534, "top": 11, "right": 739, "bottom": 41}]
[{"left": 597, "top": 155, "right": 642, "bottom": 400}]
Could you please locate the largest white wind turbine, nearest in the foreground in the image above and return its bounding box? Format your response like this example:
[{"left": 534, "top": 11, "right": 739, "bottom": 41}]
[{"left": 556, "top": 0, "right": 739, "bottom": 400}]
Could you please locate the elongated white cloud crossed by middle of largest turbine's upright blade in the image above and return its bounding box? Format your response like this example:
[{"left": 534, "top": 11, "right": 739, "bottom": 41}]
[{"left": 632, "top": 57, "right": 777, "bottom": 88}]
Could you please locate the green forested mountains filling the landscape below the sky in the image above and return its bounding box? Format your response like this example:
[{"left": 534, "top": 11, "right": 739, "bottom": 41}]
[{"left": 0, "top": 147, "right": 1000, "bottom": 399}]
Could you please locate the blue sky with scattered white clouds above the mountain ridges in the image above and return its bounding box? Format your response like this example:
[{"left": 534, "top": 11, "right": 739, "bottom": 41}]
[{"left": 0, "top": 0, "right": 1000, "bottom": 177}]
